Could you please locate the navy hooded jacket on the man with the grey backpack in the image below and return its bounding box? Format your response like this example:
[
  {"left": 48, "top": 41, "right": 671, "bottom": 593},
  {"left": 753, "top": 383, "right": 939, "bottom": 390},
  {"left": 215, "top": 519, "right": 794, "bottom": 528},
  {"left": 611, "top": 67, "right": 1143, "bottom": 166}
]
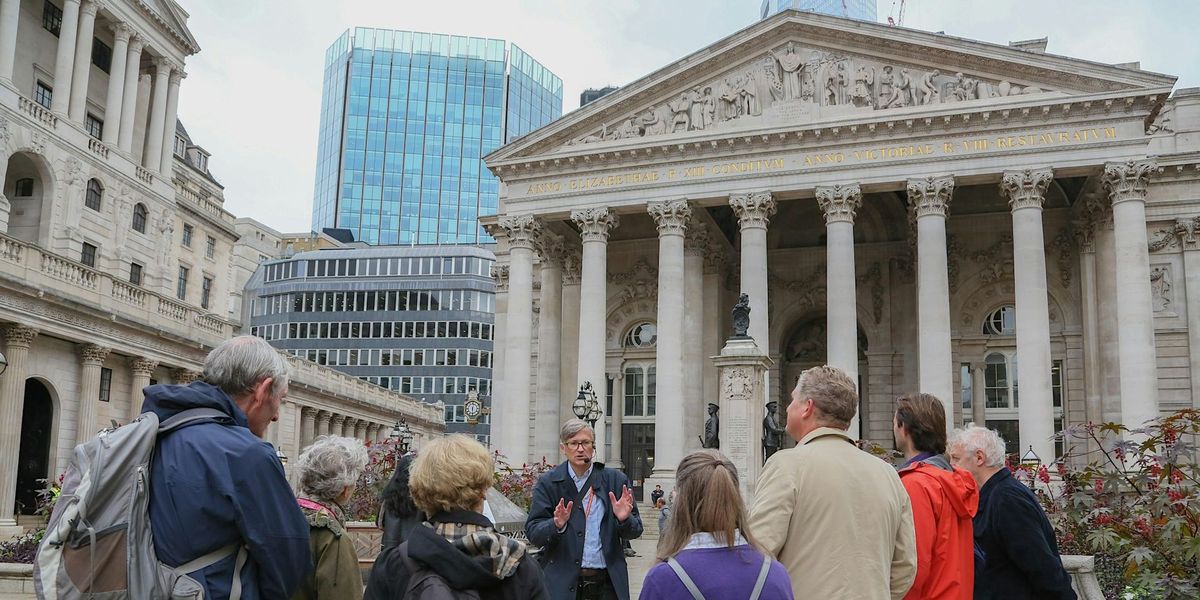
[{"left": 142, "top": 382, "right": 312, "bottom": 600}]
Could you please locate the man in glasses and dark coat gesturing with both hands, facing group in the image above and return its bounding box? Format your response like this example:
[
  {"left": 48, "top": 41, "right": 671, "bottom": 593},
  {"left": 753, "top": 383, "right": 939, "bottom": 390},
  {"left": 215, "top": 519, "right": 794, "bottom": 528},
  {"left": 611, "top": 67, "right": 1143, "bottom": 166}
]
[{"left": 526, "top": 419, "right": 642, "bottom": 600}]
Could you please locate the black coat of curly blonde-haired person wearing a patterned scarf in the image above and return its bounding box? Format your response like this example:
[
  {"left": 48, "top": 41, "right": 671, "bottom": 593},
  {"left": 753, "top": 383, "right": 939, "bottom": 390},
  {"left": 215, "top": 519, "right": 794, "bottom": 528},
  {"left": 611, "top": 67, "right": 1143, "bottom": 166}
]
[{"left": 362, "top": 511, "right": 550, "bottom": 600}]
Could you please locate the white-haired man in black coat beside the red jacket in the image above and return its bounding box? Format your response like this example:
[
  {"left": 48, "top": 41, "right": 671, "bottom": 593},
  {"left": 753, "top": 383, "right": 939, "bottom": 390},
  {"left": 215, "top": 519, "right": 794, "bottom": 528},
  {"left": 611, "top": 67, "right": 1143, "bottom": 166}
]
[{"left": 949, "top": 427, "right": 1075, "bottom": 600}]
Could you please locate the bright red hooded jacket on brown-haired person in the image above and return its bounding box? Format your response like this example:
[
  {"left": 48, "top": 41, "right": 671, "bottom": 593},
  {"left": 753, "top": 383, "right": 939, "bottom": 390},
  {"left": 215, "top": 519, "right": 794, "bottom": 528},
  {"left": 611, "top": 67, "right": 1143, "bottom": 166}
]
[{"left": 900, "top": 456, "right": 979, "bottom": 600}]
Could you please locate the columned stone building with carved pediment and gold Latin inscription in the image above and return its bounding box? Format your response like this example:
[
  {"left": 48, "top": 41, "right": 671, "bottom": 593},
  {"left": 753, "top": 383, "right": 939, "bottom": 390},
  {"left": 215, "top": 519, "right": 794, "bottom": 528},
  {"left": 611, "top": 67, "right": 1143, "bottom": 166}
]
[{"left": 485, "top": 11, "right": 1200, "bottom": 499}]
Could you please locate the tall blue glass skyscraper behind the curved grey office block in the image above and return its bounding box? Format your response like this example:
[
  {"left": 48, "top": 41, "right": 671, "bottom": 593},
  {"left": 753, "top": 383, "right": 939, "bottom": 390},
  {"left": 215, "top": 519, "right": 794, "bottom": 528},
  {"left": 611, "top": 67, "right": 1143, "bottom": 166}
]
[{"left": 312, "top": 28, "right": 563, "bottom": 245}]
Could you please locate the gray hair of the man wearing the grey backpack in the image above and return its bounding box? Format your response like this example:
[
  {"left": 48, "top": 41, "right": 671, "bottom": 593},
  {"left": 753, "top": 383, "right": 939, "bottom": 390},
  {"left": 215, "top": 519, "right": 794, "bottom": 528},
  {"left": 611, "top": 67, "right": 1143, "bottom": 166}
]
[{"left": 204, "top": 336, "right": 288, "bottom": 398}]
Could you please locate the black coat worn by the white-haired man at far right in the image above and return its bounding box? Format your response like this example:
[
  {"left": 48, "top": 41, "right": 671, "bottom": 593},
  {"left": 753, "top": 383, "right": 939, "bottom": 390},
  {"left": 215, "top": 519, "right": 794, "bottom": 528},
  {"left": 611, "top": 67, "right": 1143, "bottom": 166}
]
[{"left": 974, "top": 469, "right": 1075, "bottom": 600}]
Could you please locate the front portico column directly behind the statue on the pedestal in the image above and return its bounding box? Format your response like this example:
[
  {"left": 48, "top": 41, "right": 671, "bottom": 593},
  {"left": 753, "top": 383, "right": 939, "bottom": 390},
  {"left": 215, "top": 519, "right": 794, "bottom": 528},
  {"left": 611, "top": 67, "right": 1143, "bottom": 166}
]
[{"left": 724, "top": 192, "right": 775, "bottom": 350}]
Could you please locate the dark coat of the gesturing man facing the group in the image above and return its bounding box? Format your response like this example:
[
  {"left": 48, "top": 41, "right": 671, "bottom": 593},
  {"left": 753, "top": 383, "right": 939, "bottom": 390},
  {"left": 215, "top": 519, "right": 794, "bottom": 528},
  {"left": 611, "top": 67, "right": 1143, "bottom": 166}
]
[{"left": 526, "top": 461, "right": 642, "bottom": 600}]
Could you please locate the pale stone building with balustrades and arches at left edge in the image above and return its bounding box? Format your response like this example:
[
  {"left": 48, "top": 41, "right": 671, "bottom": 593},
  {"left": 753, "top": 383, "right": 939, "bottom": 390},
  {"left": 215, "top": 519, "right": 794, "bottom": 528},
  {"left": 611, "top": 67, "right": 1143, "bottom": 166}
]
[{"left": 0, "top": 0, "right": 444, "bottom": 539}]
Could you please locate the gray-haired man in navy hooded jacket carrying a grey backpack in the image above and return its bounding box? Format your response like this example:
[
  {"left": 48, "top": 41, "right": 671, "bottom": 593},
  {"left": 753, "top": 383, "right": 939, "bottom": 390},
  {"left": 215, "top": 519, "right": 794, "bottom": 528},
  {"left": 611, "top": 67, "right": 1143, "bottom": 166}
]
[{"left": 142, "top": 336, "right": 312, "bottom": 600}]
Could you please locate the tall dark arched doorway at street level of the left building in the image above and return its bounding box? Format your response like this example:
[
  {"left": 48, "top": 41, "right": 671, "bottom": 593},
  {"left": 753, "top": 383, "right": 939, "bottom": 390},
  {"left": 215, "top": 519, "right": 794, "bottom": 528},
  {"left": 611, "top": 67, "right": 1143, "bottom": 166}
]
[{"left": 16, "top": 378, "right": 54, "bottom": 515}]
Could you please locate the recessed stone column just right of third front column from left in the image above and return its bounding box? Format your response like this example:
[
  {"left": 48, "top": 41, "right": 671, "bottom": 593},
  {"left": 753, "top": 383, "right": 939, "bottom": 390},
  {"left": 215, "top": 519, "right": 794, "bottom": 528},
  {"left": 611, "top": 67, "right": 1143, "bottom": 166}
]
[{"left": 680, "top": 223, "right": 709, "bottom": 450}]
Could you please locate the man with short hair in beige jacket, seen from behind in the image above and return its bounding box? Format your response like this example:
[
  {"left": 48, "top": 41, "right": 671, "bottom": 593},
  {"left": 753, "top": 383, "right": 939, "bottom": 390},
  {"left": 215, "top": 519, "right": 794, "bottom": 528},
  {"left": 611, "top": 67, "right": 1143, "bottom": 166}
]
[{"left": 749, "top": 366, "right": 917, "bottom": 600}]
